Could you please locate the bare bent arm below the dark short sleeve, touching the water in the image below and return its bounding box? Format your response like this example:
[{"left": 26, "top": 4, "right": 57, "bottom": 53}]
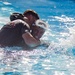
[{"left": 22, "top": 32, "right": 41, "bottom": 47}]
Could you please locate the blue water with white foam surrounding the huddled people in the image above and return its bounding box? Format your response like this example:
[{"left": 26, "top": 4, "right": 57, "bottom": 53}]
[{"left": 0, "top": 0, "right": 75, "bottom": 75}]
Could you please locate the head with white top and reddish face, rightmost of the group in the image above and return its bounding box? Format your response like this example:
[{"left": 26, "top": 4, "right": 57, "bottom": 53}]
[{"left": 34, "top": 20, "right": 47, "bottom": 39}]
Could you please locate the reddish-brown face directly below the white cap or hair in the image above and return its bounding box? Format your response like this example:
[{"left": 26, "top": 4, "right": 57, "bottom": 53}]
[{"left": 33, "top": 26, "right": 45, "bottom": 39}]
